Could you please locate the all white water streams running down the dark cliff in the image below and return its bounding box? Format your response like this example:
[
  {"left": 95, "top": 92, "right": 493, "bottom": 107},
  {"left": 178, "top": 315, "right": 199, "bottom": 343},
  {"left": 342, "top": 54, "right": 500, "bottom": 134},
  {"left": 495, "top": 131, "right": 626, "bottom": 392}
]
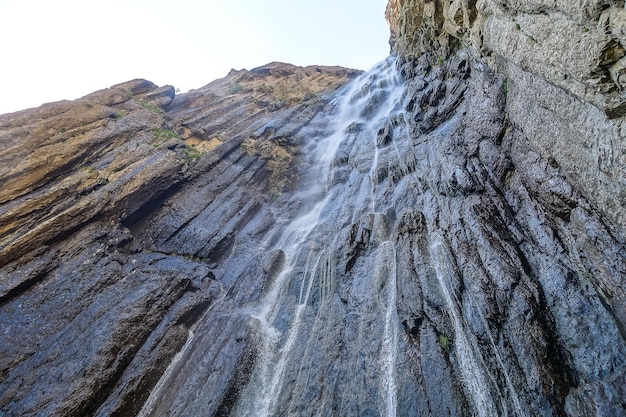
[{"left": 139, "top": 55, "right": 523, "bottom": 417}]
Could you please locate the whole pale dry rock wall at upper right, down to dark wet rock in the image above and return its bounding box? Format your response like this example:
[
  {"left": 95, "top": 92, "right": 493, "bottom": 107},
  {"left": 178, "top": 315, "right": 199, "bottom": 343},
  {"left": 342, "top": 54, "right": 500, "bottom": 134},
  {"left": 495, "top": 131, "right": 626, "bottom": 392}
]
[{"left": 386, "top": 0, "right": 626, "bottom": 234}]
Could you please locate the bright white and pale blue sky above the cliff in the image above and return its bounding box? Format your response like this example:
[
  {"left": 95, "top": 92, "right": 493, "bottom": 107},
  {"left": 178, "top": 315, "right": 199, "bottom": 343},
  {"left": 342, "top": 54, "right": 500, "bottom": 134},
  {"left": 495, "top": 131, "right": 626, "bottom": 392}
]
[{"left": 0, "top": 0, "right": 389, "bottom": 114}]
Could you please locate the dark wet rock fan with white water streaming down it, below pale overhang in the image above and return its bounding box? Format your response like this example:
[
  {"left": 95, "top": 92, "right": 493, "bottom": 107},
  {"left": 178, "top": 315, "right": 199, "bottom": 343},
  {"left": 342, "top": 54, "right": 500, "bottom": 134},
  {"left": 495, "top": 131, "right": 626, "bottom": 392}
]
[{"left": 142, "top": 52, "right": 626, "bottom": 416}]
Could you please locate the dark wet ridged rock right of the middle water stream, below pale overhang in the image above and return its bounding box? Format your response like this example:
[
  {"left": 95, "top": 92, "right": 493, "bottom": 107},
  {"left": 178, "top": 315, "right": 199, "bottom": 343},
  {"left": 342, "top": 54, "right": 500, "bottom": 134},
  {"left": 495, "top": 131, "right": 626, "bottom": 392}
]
[{"left": 395, "top": 52, "right": 626, "bottom": 416}]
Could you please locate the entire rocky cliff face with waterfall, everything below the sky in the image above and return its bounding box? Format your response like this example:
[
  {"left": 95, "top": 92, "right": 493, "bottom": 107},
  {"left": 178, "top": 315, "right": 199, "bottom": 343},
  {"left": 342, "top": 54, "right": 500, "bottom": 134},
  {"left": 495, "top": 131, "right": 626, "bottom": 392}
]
[{"left": 0, "top": 0, "right": 626, "bottom": 417}]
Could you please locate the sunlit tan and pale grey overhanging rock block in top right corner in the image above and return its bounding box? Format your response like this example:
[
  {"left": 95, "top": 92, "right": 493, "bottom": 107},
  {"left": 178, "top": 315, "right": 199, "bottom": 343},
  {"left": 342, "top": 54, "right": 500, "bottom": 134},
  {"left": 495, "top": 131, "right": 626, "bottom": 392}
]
[{"left": 386, "top": 0, "right": 626, "bottom": 110}]
